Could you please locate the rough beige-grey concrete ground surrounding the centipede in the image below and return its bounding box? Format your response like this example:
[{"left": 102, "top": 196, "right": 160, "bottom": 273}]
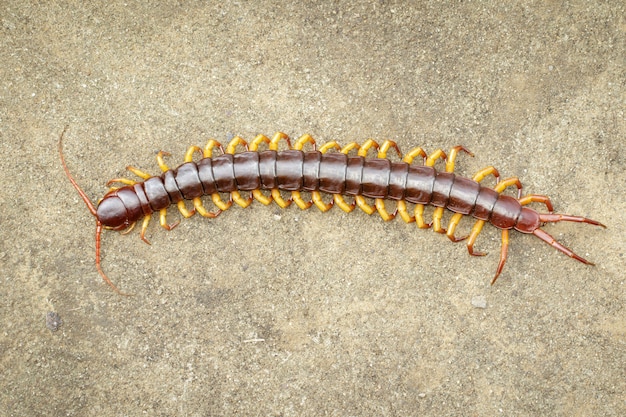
[{"left": 0, "top": 1, "right": 626, "bottom": 416}]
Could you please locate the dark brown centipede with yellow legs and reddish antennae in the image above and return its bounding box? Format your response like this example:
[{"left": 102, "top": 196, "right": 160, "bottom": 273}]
[{"left": 58, "top": 126, "right": 606, "bottom": 295}]
